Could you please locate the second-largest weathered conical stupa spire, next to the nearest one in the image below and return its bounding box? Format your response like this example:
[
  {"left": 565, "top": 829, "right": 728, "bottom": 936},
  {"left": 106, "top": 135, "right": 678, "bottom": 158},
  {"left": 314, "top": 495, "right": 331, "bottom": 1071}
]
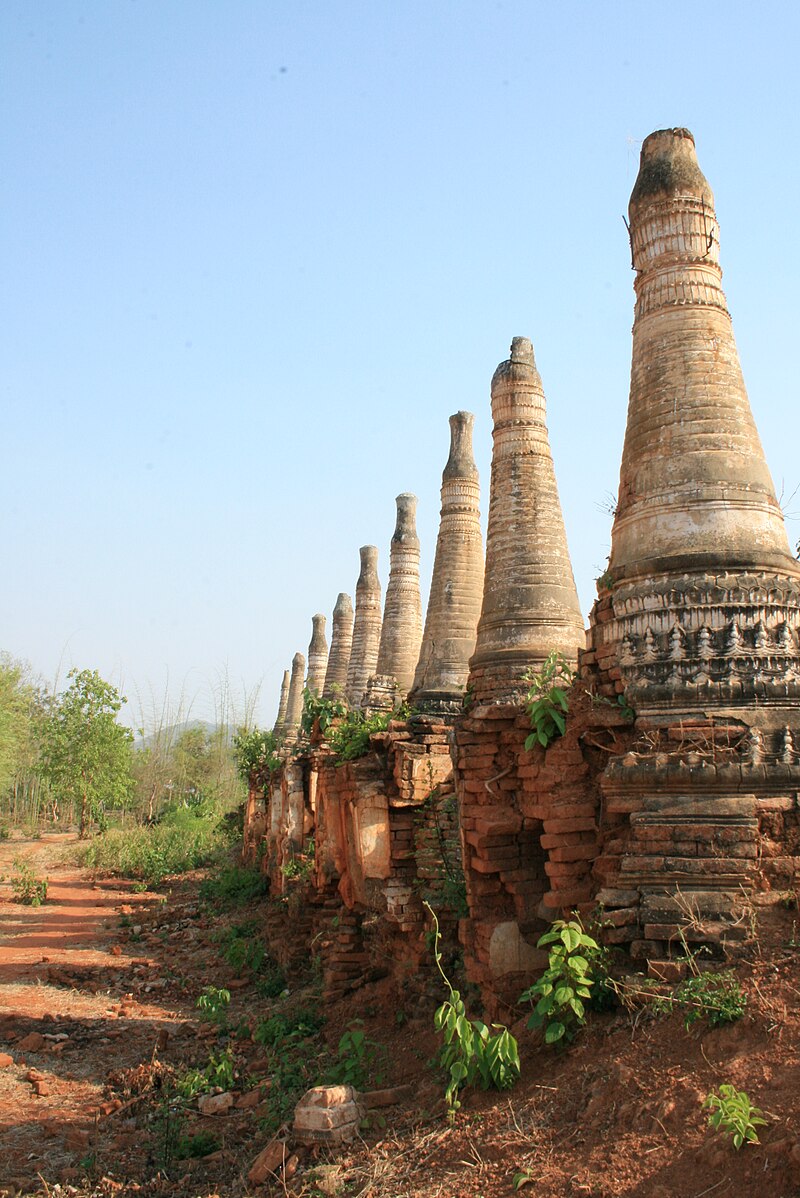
[{"left": 469, "top": 337, "right": 586, "bottom": 702}]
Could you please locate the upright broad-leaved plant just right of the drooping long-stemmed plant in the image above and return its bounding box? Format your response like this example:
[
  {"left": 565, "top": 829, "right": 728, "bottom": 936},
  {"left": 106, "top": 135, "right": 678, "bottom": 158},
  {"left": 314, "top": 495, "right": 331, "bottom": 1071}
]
[{"left": 520, "top": 919, "right": 602, "bottom": 1045}]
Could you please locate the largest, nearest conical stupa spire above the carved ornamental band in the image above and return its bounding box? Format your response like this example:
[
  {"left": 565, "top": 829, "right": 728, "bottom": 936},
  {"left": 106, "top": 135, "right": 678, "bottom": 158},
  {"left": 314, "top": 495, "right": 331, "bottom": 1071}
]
[{"left": 610, "top": 129, "right": 796, "bottom": 581}]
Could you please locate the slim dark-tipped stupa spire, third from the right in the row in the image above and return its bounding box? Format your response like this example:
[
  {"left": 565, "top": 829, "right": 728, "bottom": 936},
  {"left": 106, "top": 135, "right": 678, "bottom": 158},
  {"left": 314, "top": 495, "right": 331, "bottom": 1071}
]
[{"left": 408, "top": 412, "right": 484, "bottom": 714}]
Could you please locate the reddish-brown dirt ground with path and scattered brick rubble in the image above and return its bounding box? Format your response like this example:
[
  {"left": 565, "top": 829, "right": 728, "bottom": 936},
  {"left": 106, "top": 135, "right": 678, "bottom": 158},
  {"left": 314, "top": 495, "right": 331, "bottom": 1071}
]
[{"left": 0, "top": 835, "right": 800, "bottom": 1198}]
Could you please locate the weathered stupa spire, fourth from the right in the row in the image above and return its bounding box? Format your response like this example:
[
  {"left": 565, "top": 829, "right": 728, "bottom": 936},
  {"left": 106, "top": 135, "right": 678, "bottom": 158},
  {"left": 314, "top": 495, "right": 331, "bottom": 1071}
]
[{"left": 365, "top": 491, "right": 423, "bottom": 710}]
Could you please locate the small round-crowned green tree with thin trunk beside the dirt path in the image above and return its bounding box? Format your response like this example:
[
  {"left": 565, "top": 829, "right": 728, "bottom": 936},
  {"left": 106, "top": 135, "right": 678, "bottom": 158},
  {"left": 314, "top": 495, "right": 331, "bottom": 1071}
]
[{"left": 42, "top": 670, "right": 133, "bottom": 837}]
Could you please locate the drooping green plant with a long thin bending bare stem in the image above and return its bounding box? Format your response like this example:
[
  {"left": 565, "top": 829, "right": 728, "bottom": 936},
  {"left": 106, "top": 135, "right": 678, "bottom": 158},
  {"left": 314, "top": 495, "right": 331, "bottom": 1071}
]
[{"left": 425, "top": 902, "right": 520, "bottom": 1123}]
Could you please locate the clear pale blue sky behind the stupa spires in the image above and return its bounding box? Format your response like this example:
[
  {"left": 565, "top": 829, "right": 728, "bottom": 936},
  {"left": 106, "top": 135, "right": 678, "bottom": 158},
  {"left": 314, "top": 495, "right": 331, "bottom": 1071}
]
[{"left": 0, "top": 0, "right": 800, "bottom": 726}]
